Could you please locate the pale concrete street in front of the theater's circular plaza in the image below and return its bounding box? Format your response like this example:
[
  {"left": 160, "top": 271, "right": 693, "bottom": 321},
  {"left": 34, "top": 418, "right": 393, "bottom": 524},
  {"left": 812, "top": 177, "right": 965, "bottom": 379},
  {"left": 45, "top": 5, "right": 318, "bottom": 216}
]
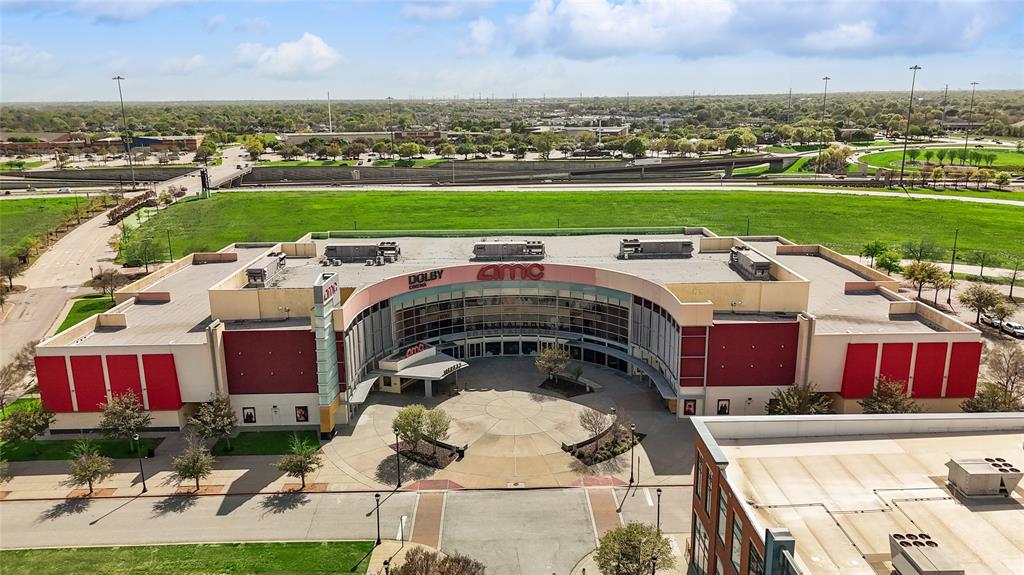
[{"left": 0, "top": 487, "right": 691, "bottom": 575}]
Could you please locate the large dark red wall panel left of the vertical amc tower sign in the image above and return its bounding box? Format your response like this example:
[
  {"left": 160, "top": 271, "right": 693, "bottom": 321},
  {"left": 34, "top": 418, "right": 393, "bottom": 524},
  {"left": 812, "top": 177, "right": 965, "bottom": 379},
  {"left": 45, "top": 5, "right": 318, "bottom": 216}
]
[{"left": 224, "top": 329, "right": 316, "bottom": 394}]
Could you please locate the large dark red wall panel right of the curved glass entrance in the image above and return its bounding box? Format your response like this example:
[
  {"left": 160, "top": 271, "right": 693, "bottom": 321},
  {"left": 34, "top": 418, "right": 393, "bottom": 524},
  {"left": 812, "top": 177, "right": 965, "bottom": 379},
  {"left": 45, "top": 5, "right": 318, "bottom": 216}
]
[{"left": 707, "top": 322, "right": 800, "bottom": 386}]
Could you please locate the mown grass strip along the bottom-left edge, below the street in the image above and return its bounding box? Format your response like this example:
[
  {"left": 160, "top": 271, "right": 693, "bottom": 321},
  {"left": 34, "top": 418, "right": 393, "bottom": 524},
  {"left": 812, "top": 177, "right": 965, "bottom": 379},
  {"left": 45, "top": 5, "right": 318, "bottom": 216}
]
[{"left": 0, "top": 541, "right": 374, "bottom": 575}]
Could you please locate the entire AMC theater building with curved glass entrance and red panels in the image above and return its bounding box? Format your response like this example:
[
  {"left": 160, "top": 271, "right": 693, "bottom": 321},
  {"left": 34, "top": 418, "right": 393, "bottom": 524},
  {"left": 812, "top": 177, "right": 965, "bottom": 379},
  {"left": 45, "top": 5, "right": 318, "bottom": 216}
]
[{"left": 36, "top": 228, "right": 981, "bottom": 434}]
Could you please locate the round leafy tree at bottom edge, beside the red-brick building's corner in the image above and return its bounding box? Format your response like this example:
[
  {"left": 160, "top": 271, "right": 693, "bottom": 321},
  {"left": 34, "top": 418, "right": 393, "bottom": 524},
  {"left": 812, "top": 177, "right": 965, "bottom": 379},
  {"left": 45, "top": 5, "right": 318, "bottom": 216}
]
[{"left": 594, "top": 522, "right": 676, "bottom": 575}]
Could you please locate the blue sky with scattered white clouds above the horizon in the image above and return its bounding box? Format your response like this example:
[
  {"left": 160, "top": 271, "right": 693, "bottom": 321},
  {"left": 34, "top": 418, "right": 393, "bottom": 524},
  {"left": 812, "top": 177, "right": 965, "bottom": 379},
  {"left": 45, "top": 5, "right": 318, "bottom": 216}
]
[{"left": 0, "top": 0, "right": 1024, "bottom": 102}]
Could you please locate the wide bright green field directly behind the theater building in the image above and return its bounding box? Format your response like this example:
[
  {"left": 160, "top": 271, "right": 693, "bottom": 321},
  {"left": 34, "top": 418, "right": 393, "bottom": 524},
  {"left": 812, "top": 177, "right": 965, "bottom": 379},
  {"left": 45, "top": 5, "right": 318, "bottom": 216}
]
[{"left": 143, "top": 190, "right": 1024, "bottom": 255}]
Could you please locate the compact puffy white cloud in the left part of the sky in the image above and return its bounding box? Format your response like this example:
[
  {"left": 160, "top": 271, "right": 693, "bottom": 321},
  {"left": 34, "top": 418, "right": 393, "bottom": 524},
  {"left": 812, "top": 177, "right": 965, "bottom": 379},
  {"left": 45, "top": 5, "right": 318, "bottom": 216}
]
[{"left": 236, "top": 32, "right": 341, "bottom": 79}]
